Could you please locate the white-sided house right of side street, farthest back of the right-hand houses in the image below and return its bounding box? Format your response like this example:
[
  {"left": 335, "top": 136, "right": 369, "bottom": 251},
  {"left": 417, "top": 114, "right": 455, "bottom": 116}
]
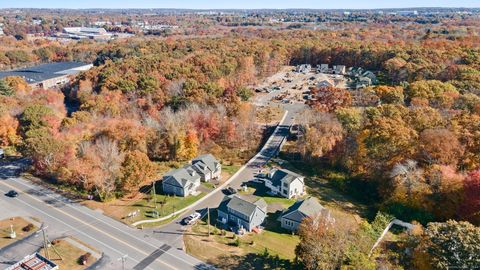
[{"left": 265, "top": 169, "right": 305, "bottom": 199}]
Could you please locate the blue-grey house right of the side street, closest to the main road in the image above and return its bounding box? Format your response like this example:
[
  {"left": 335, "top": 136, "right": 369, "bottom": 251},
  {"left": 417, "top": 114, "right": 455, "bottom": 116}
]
[{"left": 217, "top": 195, "right": 267, "bottom": 232}]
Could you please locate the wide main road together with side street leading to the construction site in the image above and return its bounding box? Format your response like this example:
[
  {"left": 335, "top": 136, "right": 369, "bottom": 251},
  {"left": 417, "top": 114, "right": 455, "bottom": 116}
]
[{"left": 0, "top": 88, "right": 303, "bottom": 270}]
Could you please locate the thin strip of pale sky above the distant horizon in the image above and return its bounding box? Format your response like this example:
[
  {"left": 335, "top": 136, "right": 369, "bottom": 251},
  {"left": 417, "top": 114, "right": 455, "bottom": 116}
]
[{"left": 0, "top": 0, "right": 480, "bottom": 10}]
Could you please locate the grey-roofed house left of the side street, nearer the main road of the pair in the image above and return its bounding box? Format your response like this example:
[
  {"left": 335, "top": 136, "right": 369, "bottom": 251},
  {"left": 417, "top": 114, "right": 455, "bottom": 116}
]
[{"left": 162, "top": 165, "right": 201, "bottom": 197}]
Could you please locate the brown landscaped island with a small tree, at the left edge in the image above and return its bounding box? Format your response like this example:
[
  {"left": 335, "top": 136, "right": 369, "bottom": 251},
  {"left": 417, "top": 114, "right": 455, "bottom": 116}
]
[{"left": 0, "top": 217, "right": 38, "bottom": 248}]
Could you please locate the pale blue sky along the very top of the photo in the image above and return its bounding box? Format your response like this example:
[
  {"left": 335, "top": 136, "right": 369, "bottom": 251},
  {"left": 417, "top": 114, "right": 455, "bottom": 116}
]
[{"left": 0, "top": 0, "right": 480, "bottom": 9}]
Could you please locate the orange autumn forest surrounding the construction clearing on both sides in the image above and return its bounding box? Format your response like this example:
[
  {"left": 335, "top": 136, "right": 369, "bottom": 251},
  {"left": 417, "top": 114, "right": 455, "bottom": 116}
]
[{"left": 0, "top": 14, "right": 480, "bottom": 269}]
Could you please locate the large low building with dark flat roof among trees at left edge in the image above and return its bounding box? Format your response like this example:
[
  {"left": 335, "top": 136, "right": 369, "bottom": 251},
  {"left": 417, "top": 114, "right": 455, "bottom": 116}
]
[{"left": 0, "top": 62, "right": 93, "bottom": 89}]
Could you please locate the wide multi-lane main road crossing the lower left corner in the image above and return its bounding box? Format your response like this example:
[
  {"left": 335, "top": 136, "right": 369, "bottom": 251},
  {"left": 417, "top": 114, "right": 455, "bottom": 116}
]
[{"left": 0, "top": 161, "right": 211, "bottom": 270}]
